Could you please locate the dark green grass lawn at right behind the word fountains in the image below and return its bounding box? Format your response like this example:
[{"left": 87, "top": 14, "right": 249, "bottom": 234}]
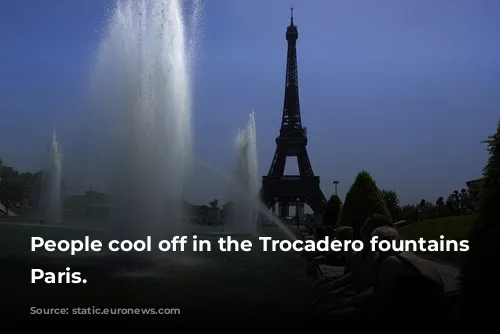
[{"left": 399, "top": 215, "right": 476, "bottom": 265}]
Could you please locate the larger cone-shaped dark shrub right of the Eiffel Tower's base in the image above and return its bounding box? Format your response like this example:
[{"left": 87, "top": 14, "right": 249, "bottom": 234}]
[{"left": 339, "top": 171, "right": 390, "bottom": 239}]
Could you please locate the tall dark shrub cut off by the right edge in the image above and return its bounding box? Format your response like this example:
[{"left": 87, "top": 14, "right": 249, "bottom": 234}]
[{"left": 461, "top": 121, "right": 500, "bottom": 322}]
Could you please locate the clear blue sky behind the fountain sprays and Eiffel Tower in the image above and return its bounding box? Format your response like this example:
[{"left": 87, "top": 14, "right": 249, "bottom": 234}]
[{"left": 0, "top": 0, "right": 500, "bottom": 203}]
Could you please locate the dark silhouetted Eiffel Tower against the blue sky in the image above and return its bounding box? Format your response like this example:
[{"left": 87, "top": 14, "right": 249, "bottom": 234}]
[{"left": 260, "top": 8, "right": 326, "bottom": 217}]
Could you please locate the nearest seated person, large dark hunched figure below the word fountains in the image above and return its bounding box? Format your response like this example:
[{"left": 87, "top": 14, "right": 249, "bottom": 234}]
[{"left": 373, "top": 227, "right": 446, "bottom": 324}]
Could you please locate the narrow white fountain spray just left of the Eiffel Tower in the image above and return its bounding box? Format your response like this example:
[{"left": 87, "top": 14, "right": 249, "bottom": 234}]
[{"left": 226, "top": 112, "right": 260, "bottom": 234}]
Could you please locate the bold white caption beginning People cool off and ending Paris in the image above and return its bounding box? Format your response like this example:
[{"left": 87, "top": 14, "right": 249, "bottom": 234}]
[{"left": 31, "top": 235, "right": 469, "bottom": 284}]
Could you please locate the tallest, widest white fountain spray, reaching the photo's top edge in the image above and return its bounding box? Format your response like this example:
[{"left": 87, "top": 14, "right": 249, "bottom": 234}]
[{"left": 93, "top": 0, "right": 200, "bottom": 238}]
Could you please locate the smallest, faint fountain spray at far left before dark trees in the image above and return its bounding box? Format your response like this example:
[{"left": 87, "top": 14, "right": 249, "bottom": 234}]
[{"left": 41, "top": 130, "right": 63, "bottom": 222}]
